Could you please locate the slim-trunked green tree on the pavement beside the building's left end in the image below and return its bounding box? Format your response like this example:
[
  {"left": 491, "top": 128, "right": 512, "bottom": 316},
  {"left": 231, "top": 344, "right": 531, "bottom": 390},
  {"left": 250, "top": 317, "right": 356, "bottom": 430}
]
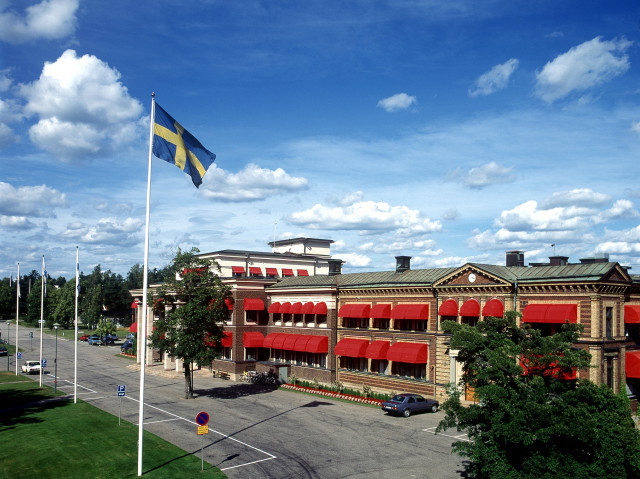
[{"left": 149, "top": 248, "right": 231, "bottom": 399}]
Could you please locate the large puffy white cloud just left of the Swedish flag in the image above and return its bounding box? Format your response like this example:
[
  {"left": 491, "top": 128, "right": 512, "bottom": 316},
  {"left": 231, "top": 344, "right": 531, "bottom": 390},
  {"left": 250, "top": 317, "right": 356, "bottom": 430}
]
[{"left": 20, "top": 50, "right": 143, "bottom": 161}]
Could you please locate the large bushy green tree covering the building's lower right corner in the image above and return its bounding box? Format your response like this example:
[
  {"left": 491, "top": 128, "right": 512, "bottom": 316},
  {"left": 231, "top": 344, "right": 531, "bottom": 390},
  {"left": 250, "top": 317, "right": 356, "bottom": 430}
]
[{"left": 438, "top": 311, "right": 640, "bottom": 479}]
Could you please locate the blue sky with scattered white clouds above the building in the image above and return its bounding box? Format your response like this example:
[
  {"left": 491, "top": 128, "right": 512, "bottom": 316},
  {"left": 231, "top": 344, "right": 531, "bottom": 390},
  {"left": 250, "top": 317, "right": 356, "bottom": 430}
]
[{"left": 0, "top": 0, "right": 640, "bottom": 277}]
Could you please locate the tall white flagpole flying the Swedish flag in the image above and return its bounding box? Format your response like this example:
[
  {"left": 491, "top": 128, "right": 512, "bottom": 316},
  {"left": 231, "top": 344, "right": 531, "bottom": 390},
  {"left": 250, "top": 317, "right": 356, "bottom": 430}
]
[{"left": 138, "top": 93, "right": 156, "bottom": 476}]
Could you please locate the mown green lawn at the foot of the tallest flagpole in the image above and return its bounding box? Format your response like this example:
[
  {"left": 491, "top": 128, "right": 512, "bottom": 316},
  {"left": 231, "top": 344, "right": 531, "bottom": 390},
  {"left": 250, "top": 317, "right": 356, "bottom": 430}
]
[{"left": 0, "top": 371, "right": 226, "bottom": 479}]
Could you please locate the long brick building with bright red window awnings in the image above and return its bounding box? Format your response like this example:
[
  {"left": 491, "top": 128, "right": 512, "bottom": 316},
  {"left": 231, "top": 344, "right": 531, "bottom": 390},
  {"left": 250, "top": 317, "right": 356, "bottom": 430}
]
[{"left": 132, "top": 242, "right": 640, "bottom": 410}]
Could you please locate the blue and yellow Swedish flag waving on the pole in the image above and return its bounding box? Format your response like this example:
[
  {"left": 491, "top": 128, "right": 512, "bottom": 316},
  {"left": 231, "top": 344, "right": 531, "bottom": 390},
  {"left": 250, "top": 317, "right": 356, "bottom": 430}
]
[{"left": 153, "top": 103, "right": 216, "bottom": 188}]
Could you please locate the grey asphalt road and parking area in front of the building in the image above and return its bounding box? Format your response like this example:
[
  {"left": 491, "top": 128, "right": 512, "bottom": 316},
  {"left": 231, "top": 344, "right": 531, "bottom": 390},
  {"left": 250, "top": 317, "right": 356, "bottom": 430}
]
[{"left": 0, "top": 328, "right": 470, "bottom": 479}]
